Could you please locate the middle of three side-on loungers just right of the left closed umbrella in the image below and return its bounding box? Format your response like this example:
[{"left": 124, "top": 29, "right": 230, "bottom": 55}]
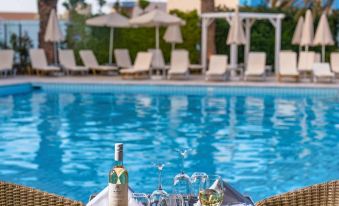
[{"left": 59, "top": 49, "right": 89, "bottom": 74}]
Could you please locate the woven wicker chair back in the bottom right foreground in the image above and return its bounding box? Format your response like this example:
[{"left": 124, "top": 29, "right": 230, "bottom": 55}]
[{"left": 256, "top": 181, "right": 339, "bottom": 206}]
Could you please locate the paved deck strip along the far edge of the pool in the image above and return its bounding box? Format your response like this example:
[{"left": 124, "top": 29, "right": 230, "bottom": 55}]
[{"left": 0, "top": 75, "right": 339, "bottom": 89}]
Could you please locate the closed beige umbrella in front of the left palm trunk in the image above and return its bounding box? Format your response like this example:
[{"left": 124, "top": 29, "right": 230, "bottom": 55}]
[{"left": 45, "top": 9, "right": 65, "bottom": 64}]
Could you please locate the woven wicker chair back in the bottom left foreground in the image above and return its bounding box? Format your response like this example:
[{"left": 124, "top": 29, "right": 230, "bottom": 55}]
[{"left": 0, "top": 181, "right": 83, "bottom": 206}]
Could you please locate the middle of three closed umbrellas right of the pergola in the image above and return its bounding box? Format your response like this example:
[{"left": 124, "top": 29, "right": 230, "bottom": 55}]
[{"left": 300, "top": 10, "right": 314, "bottom": 51}]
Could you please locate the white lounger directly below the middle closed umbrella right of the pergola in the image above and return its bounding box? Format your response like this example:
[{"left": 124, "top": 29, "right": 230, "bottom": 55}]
[{"left": 298, "top": 52, "right": 316, "bottom": 76}]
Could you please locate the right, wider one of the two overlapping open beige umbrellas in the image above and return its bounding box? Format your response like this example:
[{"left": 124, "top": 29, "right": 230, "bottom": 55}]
[{"left": 129, "top": 9, "right": 183, "bottom": 49}]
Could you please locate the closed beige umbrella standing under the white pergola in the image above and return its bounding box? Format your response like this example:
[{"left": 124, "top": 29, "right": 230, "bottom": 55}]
[{"left": 227, "top": 7, "right": 246, "bottom": 67}]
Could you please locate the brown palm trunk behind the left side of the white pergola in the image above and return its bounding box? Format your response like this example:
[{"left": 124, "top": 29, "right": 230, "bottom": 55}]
[{"left": 201, "top": 0, "right": 215, "bottom": 56}]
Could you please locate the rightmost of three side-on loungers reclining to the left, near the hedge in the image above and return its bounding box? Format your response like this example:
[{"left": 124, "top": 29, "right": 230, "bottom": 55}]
[{"left": 79, "top": 50, "right": 117, "bottom": 74}]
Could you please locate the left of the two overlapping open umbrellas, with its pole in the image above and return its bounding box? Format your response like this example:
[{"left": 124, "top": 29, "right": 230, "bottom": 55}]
[{"left": 86, "top": 12, "right": 129, "bottom": 64}]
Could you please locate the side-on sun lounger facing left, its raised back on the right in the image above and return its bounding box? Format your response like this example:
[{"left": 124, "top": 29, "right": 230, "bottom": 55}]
[{"left": 120, "top": 52, "right": 152, "bottom": 79}]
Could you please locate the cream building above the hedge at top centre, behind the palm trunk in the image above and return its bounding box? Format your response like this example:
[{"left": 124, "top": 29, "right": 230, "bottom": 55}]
[{"left": 167, "top": 0, "right": 239, "bottom": 14}]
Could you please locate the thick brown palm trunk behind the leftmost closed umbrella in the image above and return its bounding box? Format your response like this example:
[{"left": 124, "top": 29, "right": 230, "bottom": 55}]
[{"left": 38, "top": 0, "right": 58, "bottom": 62}]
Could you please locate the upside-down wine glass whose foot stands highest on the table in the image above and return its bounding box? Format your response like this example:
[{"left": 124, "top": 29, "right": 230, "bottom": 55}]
[{"left": 173, "top": 149, "right": 192, "bottom": 196}]
